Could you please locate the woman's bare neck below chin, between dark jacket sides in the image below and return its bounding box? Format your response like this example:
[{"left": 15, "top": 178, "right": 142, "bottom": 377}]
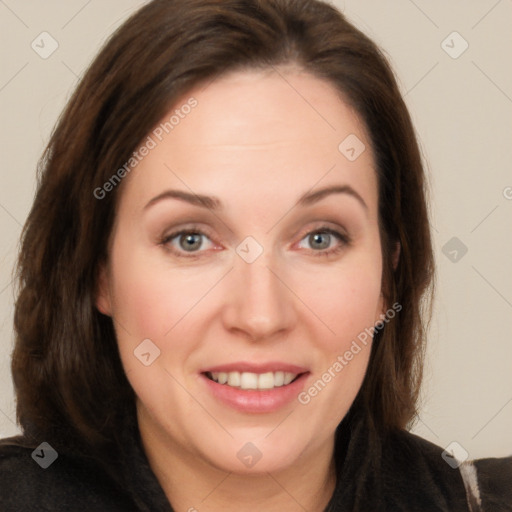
[{"left": 139, "top": 408, "right": 336, "bottom": 512}]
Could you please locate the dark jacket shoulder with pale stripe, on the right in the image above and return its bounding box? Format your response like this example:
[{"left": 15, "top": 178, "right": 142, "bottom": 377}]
[{"left": 383, "top": 430, "right": 512, "bottom": 512}]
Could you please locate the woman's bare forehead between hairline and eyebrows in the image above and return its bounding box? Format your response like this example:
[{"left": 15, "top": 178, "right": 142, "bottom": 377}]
[{"left": 118, "top": 65, "right": 376, "bottom": 216}]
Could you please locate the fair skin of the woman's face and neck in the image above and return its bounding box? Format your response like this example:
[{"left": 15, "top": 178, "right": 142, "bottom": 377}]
[{"left": 97, "top": 69, "right": 385, "bottom": 512}]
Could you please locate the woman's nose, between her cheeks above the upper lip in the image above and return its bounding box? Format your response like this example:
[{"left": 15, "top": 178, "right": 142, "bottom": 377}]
[{"left": 222, "top": 252, "right": 296, "bottom": 341}]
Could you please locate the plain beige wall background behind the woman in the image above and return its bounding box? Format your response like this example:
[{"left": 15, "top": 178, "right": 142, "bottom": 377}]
[{"left": 0, "top": 0, "right": 512, "bottom": 458}]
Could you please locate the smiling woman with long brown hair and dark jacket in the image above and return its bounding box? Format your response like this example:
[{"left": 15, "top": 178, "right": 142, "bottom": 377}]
[{"left": 0, "top": 0, "right": 510, "bottom": 511}]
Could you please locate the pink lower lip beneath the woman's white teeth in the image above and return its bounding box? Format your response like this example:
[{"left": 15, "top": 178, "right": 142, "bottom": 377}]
[{"left": 201, "top": 372, "right": 309, "bottom": 414}]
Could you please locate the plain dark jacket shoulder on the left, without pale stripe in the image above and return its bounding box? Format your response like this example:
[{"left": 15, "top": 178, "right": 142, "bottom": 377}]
[{"left": 0, "top": 437, "right": 136, "bottom": 512}]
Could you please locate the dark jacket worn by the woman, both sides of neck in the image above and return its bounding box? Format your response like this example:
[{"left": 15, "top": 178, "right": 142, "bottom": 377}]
[{"left": 0, "top": 412, "right": 512, "bottom": 512}]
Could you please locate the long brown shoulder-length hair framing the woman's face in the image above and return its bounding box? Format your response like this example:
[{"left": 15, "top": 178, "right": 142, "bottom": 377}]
[{"left": 8, "top": 0, "right": 434, "bottom": 466}]
